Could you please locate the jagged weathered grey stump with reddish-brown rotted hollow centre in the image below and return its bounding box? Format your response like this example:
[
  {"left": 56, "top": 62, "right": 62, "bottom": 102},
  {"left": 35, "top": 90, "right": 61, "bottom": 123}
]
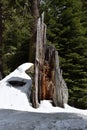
[{"left": 32, "top": 14, "right": 68, "bottom": 108}]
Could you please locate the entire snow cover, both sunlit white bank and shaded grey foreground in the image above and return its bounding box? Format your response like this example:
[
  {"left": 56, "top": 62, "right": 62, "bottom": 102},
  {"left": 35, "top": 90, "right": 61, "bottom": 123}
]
[{"left": 0, "top": 63, "right": 87, "bottom": 130}]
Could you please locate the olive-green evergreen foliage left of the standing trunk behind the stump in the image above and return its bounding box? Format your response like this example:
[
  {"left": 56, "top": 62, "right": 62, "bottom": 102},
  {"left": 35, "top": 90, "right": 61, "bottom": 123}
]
[{"left": 3, "top": 0, "right": 32, "bottom": 74}]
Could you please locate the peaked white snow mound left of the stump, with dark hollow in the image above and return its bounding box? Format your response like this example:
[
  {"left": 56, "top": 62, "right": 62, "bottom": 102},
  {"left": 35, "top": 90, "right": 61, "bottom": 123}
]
[{"left": 0, "top": 63, "right": 33, "bottom": 111}]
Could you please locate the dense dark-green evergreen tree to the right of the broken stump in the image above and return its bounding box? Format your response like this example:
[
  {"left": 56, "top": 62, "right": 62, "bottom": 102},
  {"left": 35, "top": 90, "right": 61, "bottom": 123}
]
[{"left": 43, "top": 0, "right": 87, "bottom": 108}]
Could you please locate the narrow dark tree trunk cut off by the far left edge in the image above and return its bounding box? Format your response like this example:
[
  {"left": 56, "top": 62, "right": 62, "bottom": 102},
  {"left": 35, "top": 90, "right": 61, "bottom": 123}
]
[{"left": 0, "top": 2, "right": 3, "bottom": 79}]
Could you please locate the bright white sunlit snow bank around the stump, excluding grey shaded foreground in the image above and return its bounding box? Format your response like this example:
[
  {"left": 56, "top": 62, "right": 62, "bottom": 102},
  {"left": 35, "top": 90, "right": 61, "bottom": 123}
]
[{"left": 0, "top": 63, "right": 87, "bottom": 115}]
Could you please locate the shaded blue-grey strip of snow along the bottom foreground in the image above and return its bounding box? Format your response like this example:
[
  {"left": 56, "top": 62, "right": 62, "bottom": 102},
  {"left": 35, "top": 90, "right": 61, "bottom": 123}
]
[{"left": 0, "top": 110, "right": 87, "bottom": 130}]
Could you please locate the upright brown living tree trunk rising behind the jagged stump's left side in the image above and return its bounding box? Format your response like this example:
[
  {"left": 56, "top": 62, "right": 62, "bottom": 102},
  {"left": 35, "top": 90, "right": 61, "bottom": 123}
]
[{"left": 29, "top": 0, "right": 40, "bottom": 63}]
